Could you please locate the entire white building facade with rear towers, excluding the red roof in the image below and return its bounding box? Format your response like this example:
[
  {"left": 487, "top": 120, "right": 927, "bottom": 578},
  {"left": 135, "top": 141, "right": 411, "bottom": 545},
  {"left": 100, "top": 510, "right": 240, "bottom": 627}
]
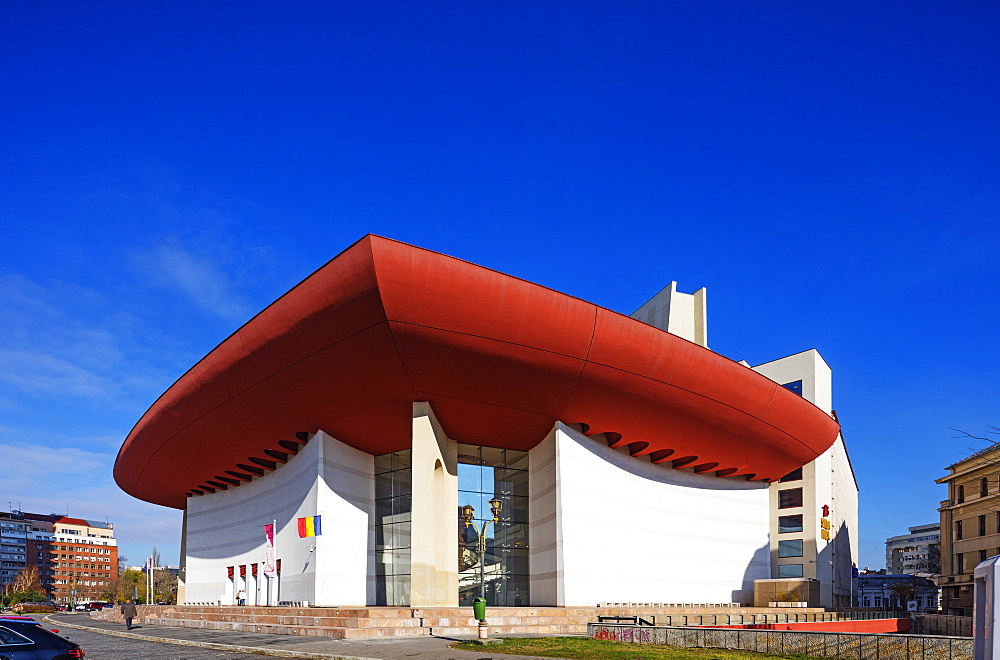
[{"left": 178, "top": 276, "right": 857, "bottom": 606}]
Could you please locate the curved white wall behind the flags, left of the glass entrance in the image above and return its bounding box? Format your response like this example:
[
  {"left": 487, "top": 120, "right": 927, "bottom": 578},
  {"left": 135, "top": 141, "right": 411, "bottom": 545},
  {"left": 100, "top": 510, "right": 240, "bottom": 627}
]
[{"left": 185, "top": 432, "right": 375, "bottom": 605}]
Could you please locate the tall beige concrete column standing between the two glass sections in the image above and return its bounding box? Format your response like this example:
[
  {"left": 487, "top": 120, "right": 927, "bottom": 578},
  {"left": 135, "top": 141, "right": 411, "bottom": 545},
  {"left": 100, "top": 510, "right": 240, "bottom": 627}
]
[{"left": 410, "top": 401, "right": 458, "bottom": 607}]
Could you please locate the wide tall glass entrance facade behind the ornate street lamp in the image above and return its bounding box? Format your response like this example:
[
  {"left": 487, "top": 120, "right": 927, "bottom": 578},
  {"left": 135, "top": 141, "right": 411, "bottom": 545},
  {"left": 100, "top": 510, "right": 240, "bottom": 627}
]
[{"left": 456, "top": 444, "right": 531, "bottom": 607}]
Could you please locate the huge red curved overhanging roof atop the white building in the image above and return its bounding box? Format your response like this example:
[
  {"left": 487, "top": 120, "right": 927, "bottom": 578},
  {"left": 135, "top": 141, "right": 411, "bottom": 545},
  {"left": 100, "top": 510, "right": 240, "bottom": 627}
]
[{"left": 115, "top": 235, "right": 839, "bottom": 508}]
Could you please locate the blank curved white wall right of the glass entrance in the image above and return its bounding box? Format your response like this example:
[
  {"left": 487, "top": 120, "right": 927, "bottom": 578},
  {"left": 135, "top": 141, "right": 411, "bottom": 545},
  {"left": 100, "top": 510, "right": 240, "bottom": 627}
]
[{"left": 529, "top": 424, "right": 770, "bottom": 606}]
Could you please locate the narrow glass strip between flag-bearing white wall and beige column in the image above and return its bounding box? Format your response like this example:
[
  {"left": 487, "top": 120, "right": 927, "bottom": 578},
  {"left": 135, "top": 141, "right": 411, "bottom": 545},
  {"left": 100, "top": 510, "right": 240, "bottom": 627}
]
[{"left": 375, "top": 449, "right": 412, "bottom": 607}]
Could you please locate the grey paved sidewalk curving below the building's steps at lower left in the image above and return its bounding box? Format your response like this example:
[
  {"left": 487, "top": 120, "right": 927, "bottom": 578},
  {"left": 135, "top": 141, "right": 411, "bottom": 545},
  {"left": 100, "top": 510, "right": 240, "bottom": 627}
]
[{"left": 44, "top": 612, "right": 564, "bottom": 660}]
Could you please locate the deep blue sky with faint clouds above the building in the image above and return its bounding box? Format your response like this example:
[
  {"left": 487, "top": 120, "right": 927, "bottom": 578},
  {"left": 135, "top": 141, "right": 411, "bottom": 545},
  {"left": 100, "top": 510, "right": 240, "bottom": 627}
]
[{"left": 0, "top": 0, "right": 1000, "bottom": 567}]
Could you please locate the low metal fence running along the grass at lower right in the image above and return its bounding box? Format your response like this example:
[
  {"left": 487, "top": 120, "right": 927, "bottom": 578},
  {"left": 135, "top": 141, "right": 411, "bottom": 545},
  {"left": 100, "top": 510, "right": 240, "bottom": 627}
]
[{"left": 587, "top": 623, "right": 972, "bottom": 660}]
